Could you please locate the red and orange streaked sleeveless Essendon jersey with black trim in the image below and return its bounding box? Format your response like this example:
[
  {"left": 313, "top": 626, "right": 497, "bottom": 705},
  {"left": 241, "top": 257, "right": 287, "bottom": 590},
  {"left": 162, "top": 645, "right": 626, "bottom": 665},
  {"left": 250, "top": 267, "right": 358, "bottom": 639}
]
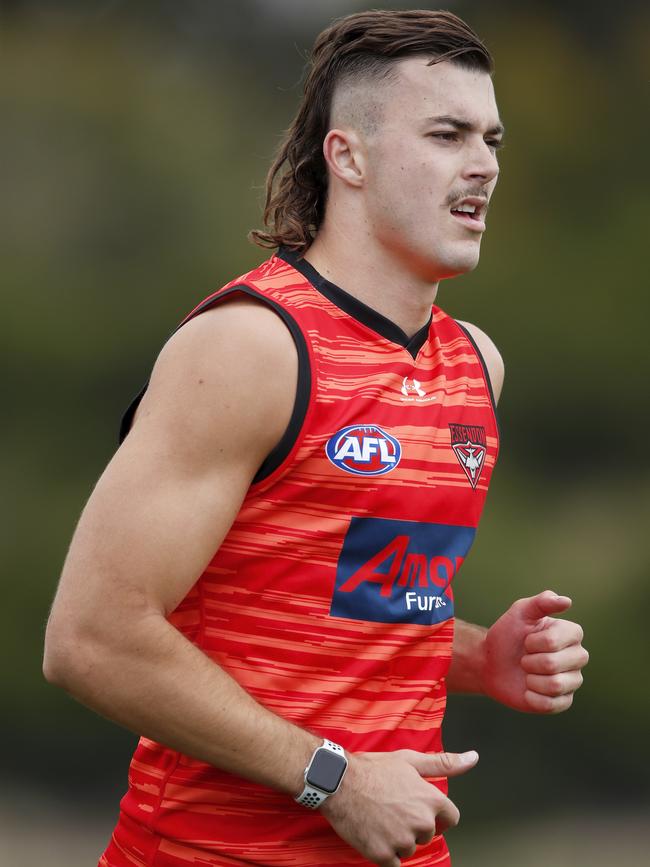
[{"left": 100, "top": 251, "right": 498, "bottom": 867}]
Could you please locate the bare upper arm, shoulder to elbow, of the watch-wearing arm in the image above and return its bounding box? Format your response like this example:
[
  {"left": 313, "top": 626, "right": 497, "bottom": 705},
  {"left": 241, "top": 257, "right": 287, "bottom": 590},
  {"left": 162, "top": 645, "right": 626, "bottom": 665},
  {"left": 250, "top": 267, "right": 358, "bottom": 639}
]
[{"left": 53, "top": 303, "right": 296, "bottom": 630}]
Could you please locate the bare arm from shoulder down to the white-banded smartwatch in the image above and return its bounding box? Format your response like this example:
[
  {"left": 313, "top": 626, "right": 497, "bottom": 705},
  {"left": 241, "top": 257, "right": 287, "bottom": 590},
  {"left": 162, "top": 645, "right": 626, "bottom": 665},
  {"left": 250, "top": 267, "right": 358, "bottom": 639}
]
[{"left": 45, "top": 301, "right": 318, "bottom": 793}]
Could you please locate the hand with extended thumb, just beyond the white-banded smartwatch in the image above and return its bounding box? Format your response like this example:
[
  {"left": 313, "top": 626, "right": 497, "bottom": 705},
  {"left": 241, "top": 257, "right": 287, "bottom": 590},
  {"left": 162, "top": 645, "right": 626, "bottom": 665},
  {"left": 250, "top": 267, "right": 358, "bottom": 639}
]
[{"left": 321, "top": 750, "right": 478, "bottom": 867}]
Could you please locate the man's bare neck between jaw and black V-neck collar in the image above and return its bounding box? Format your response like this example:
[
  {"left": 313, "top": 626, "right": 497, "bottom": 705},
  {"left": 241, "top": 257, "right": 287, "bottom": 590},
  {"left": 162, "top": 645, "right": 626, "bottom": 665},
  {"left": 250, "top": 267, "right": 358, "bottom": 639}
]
[{"left": 304, "top": 220, "right": 438, "bottom": 337}]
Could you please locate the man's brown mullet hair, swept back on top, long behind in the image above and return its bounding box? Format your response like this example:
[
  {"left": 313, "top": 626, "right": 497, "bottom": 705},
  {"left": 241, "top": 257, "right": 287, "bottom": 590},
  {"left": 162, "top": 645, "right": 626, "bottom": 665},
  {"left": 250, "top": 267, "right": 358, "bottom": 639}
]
[{"left": 249, "top": 9, "right": 493, "bottom": 253}]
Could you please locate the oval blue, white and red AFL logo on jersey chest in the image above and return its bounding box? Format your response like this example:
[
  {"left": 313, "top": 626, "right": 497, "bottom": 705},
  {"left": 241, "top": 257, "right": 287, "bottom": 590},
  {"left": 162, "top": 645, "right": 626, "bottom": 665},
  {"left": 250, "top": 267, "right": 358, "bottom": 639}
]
[{"left": 325, "top": 424, "right": 402, "bottom": 476}]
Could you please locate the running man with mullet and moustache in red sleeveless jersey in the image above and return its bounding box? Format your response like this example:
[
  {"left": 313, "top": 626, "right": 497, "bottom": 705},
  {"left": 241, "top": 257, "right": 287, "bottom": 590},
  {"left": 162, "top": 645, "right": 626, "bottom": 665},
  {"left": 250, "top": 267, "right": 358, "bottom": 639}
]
[{"left": 45, "top": 11, "right": 587, "bottom": 867}]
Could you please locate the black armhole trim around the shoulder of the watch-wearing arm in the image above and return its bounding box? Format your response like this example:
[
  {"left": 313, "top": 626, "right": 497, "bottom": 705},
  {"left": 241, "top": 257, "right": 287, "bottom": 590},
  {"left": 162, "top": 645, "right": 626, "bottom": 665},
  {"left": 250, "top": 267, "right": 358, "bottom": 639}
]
[{"left": 119, "top": 284, "right": 312, "bottom": 485}]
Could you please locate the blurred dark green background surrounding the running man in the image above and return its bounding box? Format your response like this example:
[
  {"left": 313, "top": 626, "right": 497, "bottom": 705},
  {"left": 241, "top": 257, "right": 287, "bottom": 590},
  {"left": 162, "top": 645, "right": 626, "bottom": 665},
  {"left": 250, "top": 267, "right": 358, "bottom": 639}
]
[{"left": 0, "top": 0, "right": 650, "bottom": 867}]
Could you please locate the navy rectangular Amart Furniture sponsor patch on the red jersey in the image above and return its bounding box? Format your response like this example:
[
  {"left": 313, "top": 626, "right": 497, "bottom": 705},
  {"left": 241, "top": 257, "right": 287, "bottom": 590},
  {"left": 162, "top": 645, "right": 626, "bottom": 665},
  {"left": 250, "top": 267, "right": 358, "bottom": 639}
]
[{"left": 330, "top": 518, "right": 476, "bottom": 625}]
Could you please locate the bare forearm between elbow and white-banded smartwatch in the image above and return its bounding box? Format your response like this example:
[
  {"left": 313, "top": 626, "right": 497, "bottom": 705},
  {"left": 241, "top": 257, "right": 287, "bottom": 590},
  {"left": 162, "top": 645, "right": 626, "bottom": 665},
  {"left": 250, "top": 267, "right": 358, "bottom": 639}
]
[{"left": 44, "top": 614, "right": 320, "bottom": 795}]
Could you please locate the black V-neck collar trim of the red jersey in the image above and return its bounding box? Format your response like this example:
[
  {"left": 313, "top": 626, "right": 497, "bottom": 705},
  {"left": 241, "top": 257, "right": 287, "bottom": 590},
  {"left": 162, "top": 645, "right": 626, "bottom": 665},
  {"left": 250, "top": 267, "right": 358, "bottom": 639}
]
[{"left": 277, "top": 247, "right": 433, "bottom": 358}]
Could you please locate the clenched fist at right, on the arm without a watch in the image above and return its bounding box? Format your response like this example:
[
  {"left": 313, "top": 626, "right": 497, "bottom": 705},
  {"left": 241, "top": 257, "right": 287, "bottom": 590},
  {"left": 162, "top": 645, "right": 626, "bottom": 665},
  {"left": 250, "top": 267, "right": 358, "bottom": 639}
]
[{"left": 482, "top": 590, "right": 589, "bottom": 713}]
